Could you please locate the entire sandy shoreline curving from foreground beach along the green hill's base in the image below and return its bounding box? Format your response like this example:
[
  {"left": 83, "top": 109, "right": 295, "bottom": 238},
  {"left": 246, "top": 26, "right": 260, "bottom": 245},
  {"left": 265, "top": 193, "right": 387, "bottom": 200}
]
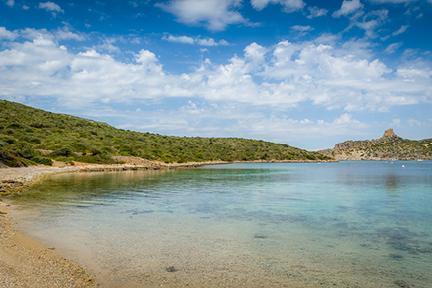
[{"left": 0, "top": 159, "right": 334, "bottom": 287}]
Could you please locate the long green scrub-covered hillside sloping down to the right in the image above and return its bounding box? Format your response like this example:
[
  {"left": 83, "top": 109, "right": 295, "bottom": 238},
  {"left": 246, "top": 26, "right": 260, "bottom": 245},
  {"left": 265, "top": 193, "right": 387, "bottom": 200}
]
[{"left": 0, "top": 100, "right": 329, "bottom": 167}]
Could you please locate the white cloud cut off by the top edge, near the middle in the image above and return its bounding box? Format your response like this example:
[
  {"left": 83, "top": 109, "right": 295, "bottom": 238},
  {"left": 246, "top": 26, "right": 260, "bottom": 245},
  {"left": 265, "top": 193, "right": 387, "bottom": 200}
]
[{"left": 156, "top": 0, "right": 248, "bottom": 31}]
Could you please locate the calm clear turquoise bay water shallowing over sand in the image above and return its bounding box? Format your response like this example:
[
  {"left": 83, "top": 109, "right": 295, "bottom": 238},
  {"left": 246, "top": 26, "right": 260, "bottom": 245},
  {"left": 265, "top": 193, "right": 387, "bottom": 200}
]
[{"left": 10, "top": 161, "right": 432, "bottom": 287}]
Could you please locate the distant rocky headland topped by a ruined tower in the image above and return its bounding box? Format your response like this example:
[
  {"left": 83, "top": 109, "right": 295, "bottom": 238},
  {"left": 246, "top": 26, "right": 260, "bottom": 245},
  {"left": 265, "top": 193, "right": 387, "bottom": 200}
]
[{"left": 319, "top": 129, "right": 432, "bottom": 160}]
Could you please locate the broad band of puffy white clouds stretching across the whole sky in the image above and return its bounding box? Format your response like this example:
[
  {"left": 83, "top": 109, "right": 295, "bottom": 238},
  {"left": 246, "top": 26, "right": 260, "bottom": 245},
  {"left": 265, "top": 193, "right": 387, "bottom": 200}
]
[{"left": 0, "top": 31, "right": 432, "bottom": 112}]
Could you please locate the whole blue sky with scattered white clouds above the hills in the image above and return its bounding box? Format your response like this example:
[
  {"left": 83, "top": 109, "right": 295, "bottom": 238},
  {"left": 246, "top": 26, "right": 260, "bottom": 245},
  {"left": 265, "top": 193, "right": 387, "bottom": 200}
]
[{"left": 0, "top": 0, "right": 432, "bottom": 149}]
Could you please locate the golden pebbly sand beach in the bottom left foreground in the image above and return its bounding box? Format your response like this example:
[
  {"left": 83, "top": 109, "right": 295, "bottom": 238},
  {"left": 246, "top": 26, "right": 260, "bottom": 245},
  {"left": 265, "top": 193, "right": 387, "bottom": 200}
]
[{"left": 0, "top": 202, "right": 96, "bottom": 288}]
